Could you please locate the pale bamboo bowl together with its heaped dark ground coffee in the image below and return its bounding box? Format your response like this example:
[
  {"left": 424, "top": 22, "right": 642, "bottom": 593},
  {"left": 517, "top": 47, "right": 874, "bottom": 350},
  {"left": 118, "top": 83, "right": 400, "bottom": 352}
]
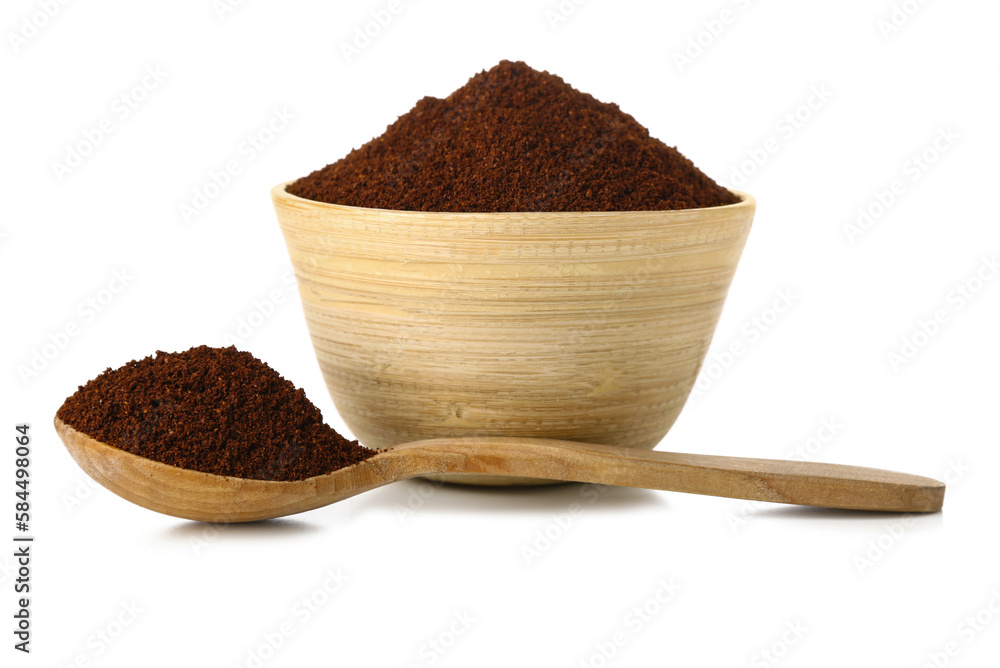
[{"left": 271, "top": 61, "right": 755, "bottom": 485}]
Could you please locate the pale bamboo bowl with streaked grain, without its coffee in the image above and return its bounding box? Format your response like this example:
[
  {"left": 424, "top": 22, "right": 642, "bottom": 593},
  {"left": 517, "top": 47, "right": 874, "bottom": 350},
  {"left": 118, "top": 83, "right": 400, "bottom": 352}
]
[{"left": 271, "top": 183, "right": 755, "bottom": 485}]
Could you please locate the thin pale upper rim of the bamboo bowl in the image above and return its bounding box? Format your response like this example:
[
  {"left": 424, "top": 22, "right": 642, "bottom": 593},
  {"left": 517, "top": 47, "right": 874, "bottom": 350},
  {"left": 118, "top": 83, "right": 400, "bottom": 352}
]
[{"left": 271, "top": 179, "right": 757, "bottom": 223}]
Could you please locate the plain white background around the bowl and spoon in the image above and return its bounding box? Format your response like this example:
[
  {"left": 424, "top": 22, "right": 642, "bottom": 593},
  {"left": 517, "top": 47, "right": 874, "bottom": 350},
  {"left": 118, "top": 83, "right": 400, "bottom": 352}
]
[{"left": 0, "top": 0, "right": 1000, "bottom": 668}]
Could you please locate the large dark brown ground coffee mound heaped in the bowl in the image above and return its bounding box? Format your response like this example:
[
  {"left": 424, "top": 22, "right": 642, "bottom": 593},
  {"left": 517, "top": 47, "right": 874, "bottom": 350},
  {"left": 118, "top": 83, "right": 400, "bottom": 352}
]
[{"left": 288, "top": 60, "right": 738, "bottom": 212}]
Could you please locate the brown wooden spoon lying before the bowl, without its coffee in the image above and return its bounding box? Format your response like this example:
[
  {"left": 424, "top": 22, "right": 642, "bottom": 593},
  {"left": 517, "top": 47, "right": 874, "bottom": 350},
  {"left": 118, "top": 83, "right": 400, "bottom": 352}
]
[{"left": 55, "top": 418, "right": 945, "bottom": 522}]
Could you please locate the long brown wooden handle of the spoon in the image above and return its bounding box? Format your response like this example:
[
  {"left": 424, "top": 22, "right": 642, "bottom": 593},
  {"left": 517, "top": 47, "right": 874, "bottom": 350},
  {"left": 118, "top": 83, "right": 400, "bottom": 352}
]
[{"left": 390, "top": 437, "right": 945, "bottom": 513}]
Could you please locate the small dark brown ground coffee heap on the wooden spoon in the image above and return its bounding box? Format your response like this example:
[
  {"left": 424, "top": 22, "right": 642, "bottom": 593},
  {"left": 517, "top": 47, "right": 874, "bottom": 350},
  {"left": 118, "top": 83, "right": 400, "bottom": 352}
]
[{"left": 56, "top": 346, "right": 375, "bottom": 480}]
